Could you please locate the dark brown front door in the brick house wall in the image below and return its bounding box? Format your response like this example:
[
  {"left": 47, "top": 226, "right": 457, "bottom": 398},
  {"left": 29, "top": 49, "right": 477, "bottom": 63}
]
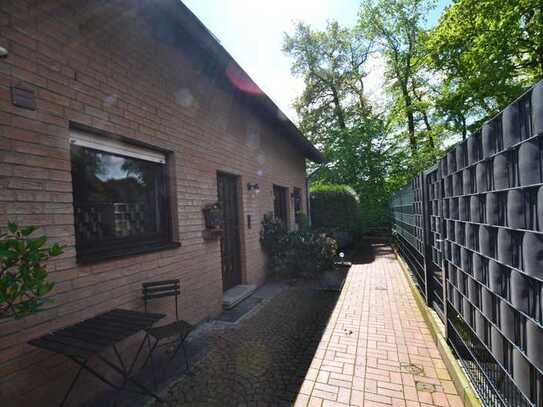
[{"left": 217, "top": 173, "right": 241, "bottom": 291}]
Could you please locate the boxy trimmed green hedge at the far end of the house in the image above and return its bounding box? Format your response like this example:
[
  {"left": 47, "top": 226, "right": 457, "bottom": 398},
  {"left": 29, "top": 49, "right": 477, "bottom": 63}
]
[{"left": 310, "top": 184, "right": 360, "bottom": 233}]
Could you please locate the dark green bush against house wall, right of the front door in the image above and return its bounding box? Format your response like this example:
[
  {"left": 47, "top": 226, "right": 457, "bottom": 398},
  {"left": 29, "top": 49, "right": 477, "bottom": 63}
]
[{"left": 260, "top": 214, "right": 337, "bottom": 276}]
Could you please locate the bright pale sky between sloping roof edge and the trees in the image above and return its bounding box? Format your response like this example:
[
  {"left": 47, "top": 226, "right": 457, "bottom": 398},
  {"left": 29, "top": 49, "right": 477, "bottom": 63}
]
[{"left": 182, "top": 0, "right": 452, "bottom": 122}]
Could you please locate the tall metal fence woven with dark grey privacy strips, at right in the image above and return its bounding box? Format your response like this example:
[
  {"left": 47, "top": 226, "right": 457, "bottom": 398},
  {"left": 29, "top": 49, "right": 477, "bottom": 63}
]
[{"left": 391, "top": 81, "right": 543, "bottom": 407}]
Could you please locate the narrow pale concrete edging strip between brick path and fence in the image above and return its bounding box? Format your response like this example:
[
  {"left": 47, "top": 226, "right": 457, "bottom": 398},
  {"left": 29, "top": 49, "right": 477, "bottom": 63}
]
[{"left": 394, "top": 248, "right": 483, "bottom": 407}]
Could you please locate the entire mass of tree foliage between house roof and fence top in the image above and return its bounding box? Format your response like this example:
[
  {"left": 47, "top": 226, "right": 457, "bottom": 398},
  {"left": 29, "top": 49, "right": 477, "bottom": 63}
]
[{"left": 284, "top": 0, "right": 543, "bottom": 233}]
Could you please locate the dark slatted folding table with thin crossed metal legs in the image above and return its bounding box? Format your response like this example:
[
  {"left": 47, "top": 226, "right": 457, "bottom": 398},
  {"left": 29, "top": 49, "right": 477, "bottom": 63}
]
[{"left": 29, "top": 309, "right": 165, "bottom": 406}]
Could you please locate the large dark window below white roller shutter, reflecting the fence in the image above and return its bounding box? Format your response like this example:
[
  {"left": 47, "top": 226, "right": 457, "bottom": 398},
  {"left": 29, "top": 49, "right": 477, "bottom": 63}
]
[{"left": 71, "top": 146, "right": 168, "bottom": 253}]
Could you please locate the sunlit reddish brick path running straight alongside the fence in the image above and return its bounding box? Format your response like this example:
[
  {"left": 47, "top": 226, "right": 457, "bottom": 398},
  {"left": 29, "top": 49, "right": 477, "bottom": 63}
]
[{"left": 295, "top": 246, "right": 463, "bottom": 407}]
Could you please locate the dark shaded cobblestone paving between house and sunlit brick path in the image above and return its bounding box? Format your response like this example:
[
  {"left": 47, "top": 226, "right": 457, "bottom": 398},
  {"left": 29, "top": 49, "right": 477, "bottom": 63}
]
[{"left": 162, "top": 288, "right": 338, "bottom": 407}]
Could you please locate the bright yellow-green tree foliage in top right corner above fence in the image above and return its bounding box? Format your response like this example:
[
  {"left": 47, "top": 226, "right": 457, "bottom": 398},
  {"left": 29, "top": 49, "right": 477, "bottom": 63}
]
[{"left": 425, "top": 0, "right": 543, "bottom": 137}]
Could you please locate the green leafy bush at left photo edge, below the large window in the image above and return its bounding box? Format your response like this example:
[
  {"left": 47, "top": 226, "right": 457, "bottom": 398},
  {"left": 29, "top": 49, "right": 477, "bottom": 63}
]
[{"left": 0, "top": 223, "right": 62, "bottom": 318}]
